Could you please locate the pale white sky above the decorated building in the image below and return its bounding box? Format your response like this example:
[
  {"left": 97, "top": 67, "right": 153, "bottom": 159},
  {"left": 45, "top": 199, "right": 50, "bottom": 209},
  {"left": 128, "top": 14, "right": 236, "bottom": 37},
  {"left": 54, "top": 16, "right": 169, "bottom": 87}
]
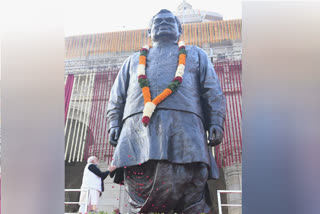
[{"left": 64, "top": 0, "right": 241, "bottom": 37}]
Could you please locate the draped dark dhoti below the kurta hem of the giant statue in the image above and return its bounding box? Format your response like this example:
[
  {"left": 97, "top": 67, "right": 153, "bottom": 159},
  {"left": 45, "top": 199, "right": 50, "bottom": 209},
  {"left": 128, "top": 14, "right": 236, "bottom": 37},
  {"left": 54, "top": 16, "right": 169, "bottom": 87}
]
[{"left": 124, "top": 160, "right": 210, "bottom": 214}]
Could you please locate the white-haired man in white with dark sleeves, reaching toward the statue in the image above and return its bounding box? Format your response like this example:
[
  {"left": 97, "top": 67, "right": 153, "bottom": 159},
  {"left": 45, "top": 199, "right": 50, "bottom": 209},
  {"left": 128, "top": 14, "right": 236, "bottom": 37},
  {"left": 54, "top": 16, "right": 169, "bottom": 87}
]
[{"left": 79, "top": 156, "right": 116, "bottom": 213}]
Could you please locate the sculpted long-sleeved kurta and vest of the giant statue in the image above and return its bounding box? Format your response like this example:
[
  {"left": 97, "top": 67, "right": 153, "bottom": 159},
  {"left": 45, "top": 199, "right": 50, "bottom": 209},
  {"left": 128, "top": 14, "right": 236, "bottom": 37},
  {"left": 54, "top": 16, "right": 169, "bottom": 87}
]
[{"left": 107, "top": 44, "right": 226, "bottom": 172}]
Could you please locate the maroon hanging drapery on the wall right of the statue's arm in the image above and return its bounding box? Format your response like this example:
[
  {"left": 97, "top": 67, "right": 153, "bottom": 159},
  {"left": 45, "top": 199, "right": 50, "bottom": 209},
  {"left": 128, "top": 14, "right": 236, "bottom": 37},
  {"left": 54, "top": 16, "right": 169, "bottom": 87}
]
[{"left": 214, "top": 60, "right": 242, "bottom": 167}]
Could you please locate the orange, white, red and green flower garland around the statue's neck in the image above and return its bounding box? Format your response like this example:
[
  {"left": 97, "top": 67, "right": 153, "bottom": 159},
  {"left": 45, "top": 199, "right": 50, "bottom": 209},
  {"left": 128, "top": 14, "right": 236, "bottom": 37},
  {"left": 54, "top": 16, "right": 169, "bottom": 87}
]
[{"left": 138, "top": 41, "right": 187, "bottom": 126}]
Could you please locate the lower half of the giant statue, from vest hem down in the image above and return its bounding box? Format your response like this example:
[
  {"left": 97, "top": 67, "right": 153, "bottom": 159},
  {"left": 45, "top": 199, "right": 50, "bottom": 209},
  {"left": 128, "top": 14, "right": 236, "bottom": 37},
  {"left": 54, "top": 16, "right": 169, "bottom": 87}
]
[{"left": 112, "top": 109, "right": 219, "bottom": 214}]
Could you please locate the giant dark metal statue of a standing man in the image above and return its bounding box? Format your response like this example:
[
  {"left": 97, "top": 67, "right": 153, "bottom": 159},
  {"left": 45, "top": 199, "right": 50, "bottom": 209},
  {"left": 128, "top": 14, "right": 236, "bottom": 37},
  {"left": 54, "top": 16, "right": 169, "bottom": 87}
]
[{"left": 107, "top": 10, "right": 226, "bottom": 214}]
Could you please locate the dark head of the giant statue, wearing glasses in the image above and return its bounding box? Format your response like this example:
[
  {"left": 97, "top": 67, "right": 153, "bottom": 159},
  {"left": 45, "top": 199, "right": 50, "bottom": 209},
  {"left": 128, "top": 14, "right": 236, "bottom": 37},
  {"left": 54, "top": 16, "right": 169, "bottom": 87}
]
[{"left": 148, "top": 9, "right": 182, "bottom": 42}]
